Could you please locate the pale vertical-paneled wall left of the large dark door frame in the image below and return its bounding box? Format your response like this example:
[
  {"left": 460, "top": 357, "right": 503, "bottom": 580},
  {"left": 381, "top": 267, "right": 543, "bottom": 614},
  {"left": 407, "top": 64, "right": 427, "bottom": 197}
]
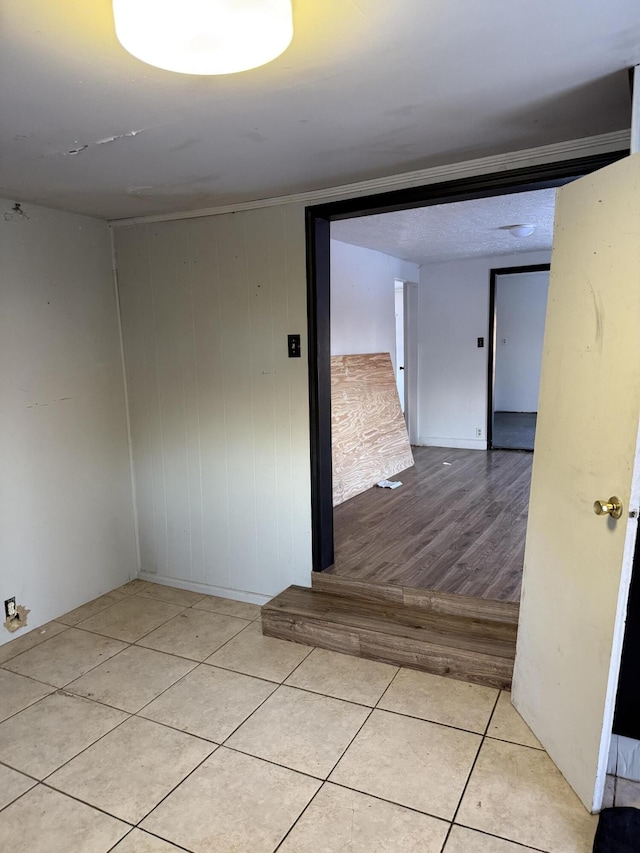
[{"left": 115, "top": 205, "right": 311, "bottom": 600}]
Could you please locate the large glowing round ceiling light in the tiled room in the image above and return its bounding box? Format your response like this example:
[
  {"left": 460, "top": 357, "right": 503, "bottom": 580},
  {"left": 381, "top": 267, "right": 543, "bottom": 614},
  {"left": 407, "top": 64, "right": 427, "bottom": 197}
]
[{"left": 113, "top": 0, "right": 293, "bottom": 74}]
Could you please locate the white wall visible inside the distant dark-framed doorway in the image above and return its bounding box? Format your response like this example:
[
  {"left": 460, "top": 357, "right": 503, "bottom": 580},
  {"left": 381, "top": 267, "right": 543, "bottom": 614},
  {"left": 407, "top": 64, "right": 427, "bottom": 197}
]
[{"left": 493, "top": 271, "right": 549, "bottom": 412}]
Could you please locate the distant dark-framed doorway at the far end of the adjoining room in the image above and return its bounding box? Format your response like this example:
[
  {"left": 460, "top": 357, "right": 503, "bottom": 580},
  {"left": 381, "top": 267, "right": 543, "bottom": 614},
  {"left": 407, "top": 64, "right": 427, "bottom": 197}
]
[{"left": 487, "top": 264, "right": 550, "bottom": 451}]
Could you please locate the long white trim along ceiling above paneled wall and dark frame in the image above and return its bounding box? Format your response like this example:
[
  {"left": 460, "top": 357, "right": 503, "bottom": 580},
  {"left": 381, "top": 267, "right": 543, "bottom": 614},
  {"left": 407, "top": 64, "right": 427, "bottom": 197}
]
[{"left": 109, "top": 130, "right": 631, "bottom": 228}]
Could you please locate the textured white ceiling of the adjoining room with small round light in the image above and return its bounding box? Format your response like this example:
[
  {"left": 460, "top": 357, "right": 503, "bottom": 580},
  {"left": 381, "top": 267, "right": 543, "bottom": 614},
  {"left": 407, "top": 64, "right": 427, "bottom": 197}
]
[{"left": 331, "top": 189, "right": 556, "bottom": 264}]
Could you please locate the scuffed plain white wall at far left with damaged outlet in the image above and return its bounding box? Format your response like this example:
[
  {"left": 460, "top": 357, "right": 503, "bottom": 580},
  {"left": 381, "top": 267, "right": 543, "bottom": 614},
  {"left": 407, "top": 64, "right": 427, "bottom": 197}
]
[{"left": 0, "top": 200, "right": 137, "bottom": 643}]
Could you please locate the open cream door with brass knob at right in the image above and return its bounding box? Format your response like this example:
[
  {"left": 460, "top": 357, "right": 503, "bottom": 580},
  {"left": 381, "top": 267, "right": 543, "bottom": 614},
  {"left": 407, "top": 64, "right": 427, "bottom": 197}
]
[{"left": 513, "top": 154, "right": 640, "bottom": 811}]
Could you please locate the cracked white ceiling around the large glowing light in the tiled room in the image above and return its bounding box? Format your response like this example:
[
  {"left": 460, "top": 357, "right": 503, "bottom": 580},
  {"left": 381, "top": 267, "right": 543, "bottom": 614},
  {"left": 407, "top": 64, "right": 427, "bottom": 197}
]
[{"left": 0, "top": 0, "right": 640, "bottom": 218}]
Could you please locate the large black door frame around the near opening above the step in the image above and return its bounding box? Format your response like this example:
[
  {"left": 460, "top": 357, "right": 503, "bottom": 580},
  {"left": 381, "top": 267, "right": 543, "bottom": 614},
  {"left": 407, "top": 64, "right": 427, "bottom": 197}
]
[{"left": 305, "top": 149, "right": 629, "bottom": 572}]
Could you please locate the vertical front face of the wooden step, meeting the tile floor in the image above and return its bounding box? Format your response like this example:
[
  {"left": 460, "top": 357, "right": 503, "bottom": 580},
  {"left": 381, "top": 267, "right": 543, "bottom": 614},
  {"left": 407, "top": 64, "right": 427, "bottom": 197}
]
[{"left": 262, "top": 610, "right": 513, "bottom": 690}]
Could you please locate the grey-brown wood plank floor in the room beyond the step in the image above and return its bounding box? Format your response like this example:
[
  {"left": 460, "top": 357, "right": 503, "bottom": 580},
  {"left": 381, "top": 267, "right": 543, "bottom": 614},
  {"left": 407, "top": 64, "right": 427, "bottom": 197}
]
[{"left": 327, "top": 447, "right": 533, "bottom": 601}]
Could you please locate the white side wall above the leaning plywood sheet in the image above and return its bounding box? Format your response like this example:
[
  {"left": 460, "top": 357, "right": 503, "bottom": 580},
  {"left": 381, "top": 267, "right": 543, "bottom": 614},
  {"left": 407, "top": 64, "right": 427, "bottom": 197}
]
[{"left": 331, "top": 240, "right": 418, "bottom": 372}]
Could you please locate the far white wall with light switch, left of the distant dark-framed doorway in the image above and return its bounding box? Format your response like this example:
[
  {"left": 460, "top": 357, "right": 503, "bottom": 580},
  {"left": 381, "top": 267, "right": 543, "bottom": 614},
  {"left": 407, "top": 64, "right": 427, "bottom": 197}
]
[{"left": 417, "top": 252, "right": 550, "bottom": 449}]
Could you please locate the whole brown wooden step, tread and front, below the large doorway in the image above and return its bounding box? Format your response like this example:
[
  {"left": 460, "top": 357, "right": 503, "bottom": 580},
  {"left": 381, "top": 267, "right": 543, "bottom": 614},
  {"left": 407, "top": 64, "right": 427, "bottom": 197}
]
[{"left": 262, "top": 586, "right": 517, "bottom": 689}]
